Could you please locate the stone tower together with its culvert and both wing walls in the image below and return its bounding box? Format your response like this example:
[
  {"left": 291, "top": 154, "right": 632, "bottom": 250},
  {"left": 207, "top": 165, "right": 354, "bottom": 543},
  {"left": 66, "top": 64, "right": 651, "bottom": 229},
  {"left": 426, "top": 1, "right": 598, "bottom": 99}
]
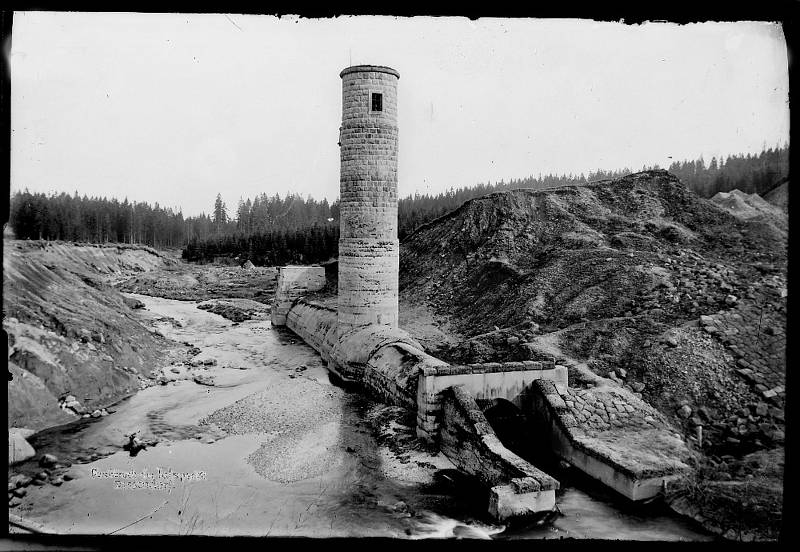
[{"left": 271, "top": 65, "right": 689, "bottom": 520}]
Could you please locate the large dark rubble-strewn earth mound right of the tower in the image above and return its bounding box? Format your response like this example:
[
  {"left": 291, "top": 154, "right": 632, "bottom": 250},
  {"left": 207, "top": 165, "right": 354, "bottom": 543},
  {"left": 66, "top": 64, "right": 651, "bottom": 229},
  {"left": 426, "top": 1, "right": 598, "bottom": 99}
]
[{"left": 400, "top": 171, "right": 788, "bottom": 540}]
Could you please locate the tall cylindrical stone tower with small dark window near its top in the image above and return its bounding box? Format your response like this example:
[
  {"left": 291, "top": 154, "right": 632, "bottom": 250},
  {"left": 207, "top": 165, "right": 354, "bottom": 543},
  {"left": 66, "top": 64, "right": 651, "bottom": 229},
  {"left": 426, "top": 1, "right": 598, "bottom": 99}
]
[{"left": 338, "top": 65, "right": 400, "bottom": 336}]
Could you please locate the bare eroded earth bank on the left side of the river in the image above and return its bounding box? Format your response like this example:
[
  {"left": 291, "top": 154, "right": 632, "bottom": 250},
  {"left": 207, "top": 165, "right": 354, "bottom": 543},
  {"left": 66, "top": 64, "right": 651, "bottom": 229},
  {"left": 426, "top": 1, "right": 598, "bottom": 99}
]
[{"left": 3, "top": 240, "right": 181, "bottom": 430}]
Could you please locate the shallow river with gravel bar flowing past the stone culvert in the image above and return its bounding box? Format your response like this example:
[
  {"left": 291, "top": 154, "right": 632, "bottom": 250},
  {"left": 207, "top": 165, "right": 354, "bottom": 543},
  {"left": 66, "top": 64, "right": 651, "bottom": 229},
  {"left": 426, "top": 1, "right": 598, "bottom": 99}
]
[{"left": 14, "top": 295, "right": 711, "bottom": 540}]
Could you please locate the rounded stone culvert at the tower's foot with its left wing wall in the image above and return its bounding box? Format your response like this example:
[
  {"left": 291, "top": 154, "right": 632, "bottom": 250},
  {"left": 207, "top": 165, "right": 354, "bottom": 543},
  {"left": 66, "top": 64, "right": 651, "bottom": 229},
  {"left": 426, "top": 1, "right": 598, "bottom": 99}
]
[{"left": 278, "top": 282, "right": 566, "bottom": 520}]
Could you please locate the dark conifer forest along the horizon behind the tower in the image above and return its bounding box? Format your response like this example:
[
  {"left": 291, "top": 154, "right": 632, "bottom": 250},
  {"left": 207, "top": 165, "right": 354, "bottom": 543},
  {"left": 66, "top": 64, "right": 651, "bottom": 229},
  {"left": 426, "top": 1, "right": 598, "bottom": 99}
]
[{"left": 9, "top": 145, "right": 789, "bottom": 265}]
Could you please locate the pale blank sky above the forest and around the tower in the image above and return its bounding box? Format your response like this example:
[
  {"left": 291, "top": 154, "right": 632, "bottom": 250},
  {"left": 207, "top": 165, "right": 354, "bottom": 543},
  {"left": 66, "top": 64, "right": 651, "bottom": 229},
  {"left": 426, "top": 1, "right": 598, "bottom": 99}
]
[{"left": 11, "top": 12, "right": 789, "bottom": 215}]
